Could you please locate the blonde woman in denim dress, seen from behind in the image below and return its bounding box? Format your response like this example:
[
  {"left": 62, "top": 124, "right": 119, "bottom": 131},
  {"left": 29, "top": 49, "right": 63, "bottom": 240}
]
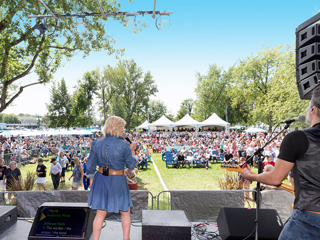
[{"left": 86, "top": 116, "right": 136, "bottom": 240}]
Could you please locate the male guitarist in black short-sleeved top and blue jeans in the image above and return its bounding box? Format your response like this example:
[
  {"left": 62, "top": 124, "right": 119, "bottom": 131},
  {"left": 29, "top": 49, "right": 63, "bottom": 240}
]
[{"left": 242, "top": 87, "right": 320, "bottom": 240}]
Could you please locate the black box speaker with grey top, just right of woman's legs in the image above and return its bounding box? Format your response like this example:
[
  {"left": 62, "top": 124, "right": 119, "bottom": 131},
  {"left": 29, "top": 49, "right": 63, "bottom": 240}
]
[{"left": 142, "top": 210, "right": 191, "bottom": 240}]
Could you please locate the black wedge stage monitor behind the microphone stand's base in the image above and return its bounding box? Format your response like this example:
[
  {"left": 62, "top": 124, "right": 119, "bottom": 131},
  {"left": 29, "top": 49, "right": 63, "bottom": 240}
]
[{"left": 217, "top": 207, "right": 283, "bottom": 240}]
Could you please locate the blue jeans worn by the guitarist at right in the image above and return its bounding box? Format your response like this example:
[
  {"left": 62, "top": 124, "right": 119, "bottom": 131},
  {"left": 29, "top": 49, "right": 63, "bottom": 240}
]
[{"left": 278, "top": 209, "right": 320, "bottom": 240}]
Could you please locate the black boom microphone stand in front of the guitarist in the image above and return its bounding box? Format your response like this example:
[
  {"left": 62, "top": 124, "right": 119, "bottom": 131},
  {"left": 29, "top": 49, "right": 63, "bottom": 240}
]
[{"left": 240, "top": 122, "right": 291, "bottom": 240}]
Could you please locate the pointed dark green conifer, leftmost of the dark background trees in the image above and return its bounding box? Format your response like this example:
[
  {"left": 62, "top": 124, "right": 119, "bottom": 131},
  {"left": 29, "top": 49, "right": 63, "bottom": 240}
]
[{"left": 46, "top": 78, "right": 73, "bottom": 128}]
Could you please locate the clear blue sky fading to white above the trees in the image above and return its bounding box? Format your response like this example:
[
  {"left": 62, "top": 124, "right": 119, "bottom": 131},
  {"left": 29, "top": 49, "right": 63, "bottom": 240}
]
[{"left": 4, "top": 0, "right": 320, "bottom": 115}]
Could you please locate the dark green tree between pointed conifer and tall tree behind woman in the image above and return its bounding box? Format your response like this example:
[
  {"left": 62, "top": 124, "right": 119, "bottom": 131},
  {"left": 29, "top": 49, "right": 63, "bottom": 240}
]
[{"left": 71, "top": 70, "right": 98, "bottom": 127}]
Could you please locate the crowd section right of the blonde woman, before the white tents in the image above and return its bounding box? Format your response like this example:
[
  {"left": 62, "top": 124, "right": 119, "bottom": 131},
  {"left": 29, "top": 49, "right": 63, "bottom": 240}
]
[{"left": 130, "top": 128, "right": 286, "bottom": 169}]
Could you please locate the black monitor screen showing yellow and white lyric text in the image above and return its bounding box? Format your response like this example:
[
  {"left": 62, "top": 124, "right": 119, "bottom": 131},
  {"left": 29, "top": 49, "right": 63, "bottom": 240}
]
[{"left": 28, "top": 202, "right": 94, "bottom": 240}]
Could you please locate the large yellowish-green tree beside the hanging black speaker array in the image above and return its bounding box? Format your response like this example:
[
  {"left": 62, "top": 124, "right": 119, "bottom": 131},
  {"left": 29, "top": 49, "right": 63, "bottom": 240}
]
[{"left": 228, "top": 46, "right": 307, "bottom": 128}]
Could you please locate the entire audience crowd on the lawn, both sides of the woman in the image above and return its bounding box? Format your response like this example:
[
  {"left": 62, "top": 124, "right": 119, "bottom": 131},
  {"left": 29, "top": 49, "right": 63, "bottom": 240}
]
[{"left": 0, "top": 127, "right": 285, "bottom": 197}]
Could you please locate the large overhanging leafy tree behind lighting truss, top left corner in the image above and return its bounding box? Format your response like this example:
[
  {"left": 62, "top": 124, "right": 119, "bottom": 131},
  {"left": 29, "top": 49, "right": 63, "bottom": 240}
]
[{"left": 0, "top": 0, "right": 138, "bottom": 112}]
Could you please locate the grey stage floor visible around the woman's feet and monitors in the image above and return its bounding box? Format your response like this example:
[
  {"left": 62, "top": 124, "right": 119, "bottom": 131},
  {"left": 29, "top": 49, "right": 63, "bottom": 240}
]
[{"left": 0, "top": 220, "right": 218, "bottom": 240}]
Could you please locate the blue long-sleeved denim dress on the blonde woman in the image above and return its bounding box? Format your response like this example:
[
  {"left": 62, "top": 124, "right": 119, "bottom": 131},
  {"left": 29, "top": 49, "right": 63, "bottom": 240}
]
[{"left": 86, "top": 134, "right": 136, "bottom": 213}]
